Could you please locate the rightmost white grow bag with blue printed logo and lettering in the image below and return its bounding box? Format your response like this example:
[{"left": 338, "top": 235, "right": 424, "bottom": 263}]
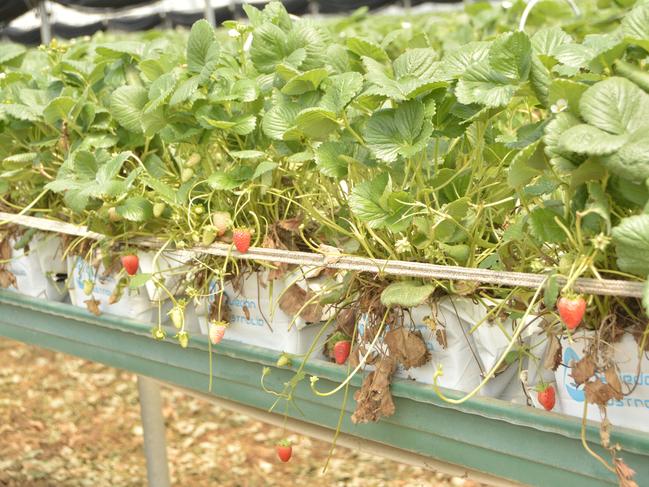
[{"left": 555, "top": 331, "right": 649, "bottom": 432}]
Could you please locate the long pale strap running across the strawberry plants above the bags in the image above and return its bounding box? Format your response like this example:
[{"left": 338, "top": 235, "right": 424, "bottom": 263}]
[{"left": 0, "top": 212, "right": 644, "bottom": 298}]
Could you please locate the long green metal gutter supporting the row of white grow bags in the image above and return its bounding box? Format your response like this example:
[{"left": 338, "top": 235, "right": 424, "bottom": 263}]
[{"left": 0, "top": 291, "right": 649, "bottom": 487}]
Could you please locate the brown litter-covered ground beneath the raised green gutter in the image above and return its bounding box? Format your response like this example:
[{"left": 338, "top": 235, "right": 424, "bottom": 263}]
[{"left": 0, "top": 339, "right": 475, "bottom": 487}]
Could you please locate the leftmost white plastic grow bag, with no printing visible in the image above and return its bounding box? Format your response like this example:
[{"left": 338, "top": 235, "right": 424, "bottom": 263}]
[{"left": 7, "top": 233, "right": 67, "bottom": 301}]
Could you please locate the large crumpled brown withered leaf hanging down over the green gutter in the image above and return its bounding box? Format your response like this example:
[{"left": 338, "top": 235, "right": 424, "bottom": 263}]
[{"left": 352, "top": 355, "right": 396, "bottom": 424}]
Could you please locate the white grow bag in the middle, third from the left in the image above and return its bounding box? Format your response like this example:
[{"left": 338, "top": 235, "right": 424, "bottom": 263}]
[{"left": 196, "top": 271, "right": 326, "bottom": 358}]
